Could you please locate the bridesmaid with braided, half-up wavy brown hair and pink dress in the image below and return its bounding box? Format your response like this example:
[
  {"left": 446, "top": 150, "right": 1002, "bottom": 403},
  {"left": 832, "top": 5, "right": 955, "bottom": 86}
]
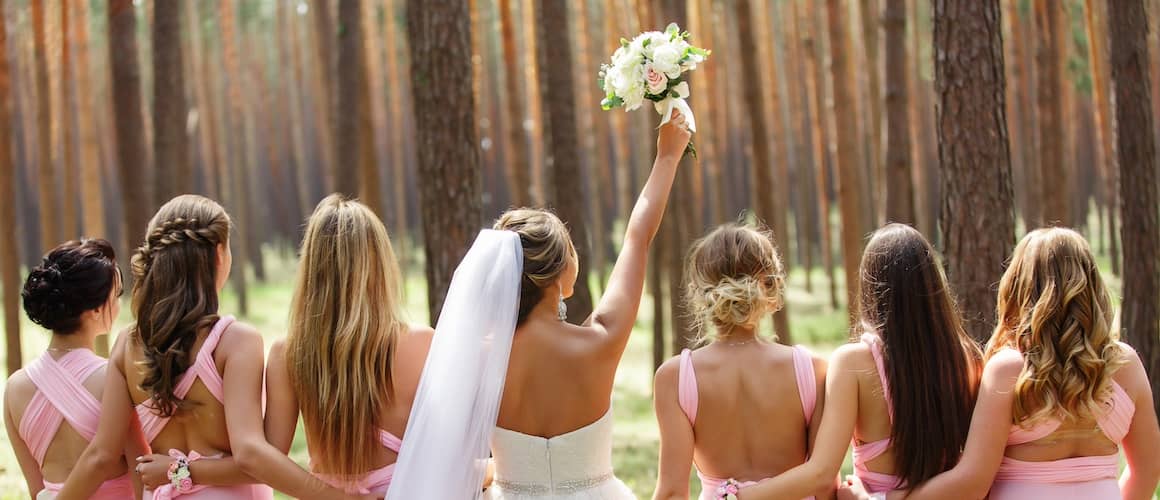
[{"left": 58, "top": 195, "right": 366, "bottom": 500}]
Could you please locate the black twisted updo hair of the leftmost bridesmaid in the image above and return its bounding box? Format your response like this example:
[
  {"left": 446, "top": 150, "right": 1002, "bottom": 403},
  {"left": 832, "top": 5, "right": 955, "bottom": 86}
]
[{"left": 20, "top": 239, "right": 121, "bottom": 335}]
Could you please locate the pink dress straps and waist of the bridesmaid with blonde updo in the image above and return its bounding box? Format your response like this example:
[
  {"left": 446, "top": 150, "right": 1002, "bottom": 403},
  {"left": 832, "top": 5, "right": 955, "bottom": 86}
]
[{"left": 676, "top": 346, "right": 818, "bottom": 500}]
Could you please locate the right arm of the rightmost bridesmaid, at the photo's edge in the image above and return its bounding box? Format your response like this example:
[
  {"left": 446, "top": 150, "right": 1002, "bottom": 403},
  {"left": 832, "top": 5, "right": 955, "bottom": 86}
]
[{"left": 1116, "top": 343, "right": 1160, "bottom": 500}]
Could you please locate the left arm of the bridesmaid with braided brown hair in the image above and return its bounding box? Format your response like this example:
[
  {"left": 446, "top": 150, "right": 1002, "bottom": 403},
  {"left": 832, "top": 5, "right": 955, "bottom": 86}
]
[{"left": 57, "top": 333, "right": 143, "bottom": 500}]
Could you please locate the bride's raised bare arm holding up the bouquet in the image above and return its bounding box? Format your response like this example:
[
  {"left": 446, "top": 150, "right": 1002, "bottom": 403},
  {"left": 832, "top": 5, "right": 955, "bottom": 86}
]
[{"left": 592, "top": 111, "right": 690, "bottom": 357}]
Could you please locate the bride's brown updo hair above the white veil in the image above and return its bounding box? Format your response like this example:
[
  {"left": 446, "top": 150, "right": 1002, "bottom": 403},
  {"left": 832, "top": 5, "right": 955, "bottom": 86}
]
[{"left": 492, "top": 209, "right": 577, "bottom": 326}]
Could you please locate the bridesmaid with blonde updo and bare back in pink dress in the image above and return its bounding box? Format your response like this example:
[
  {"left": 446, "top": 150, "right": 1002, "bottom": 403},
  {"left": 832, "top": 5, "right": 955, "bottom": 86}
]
[{"left": 653, "top": 225, "right": 834, "bottom": 500}]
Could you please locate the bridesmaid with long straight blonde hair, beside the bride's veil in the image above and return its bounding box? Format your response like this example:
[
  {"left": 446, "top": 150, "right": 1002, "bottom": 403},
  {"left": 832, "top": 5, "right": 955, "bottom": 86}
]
[{"left": 266, "top": 195, "right": 434, "bottom": 495}]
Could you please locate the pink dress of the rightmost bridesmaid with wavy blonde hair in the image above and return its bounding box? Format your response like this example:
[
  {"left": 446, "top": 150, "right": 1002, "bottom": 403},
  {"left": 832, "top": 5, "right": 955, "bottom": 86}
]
[{"left": 991, "top": 348, "right": 1136, "bottom": 500}]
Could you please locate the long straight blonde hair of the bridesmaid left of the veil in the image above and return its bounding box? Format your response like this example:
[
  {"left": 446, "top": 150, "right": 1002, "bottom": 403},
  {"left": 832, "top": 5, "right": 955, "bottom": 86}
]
[{"left": 287, "top": 195, "right": 406, "bottom": 480}]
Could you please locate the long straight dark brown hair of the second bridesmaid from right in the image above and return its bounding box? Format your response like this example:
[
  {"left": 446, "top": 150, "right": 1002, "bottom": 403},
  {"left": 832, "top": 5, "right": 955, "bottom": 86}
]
[{"left": 858, "top": 224, "right": 981, "bottom": 487}]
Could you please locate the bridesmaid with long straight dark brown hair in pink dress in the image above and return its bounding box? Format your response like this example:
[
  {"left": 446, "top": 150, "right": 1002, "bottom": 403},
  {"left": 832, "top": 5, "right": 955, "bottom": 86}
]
[{"left": 740, "top": 224, "right": 980, "bottom": 500}]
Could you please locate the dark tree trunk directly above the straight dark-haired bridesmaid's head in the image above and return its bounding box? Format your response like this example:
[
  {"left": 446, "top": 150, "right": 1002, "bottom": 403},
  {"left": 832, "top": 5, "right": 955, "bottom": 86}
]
[{"left": 883, "top": 0, "right": 915, "bottom": 224}]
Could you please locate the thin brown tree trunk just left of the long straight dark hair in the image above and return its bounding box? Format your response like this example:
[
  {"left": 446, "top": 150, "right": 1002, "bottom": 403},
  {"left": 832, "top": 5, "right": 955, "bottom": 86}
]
[{"left": 826, "top": 0, "right": 867, "bottom": 321}]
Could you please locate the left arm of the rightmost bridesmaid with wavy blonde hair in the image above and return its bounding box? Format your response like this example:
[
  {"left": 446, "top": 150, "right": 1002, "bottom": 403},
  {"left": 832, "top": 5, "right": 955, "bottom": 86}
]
[{"left": 889, "top": 350, "right": 1023, "bottom": 500}]
